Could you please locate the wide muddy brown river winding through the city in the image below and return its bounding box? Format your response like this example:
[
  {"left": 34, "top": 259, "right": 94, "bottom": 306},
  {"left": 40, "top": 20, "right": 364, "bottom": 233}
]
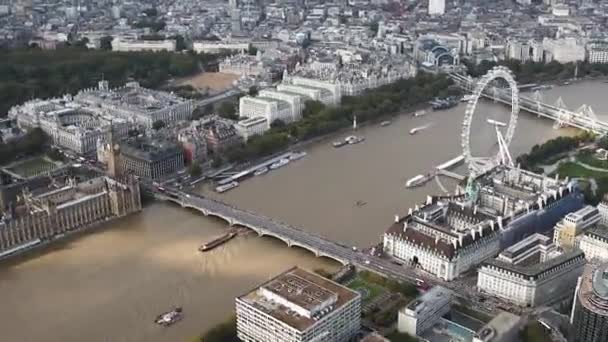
[{"left": 0, "top": 82, "right": 608, "bottom": 342}]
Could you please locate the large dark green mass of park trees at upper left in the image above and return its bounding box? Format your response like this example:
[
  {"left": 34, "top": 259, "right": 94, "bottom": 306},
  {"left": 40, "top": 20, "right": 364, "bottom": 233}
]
[{"left": 0, "top": 46, "right": 221, "bottom": 116}]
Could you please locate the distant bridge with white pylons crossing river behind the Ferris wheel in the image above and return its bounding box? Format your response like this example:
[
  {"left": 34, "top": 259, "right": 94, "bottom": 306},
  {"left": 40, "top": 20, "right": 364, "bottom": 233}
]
[{"left": 450, "top": 74, "right": 608, "bottom": 134}]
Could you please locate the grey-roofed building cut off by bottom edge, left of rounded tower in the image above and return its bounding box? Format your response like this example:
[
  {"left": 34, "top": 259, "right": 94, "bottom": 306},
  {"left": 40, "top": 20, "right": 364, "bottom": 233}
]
[{"left": 473, "top": 311, "right": 522, "bottom": 342}]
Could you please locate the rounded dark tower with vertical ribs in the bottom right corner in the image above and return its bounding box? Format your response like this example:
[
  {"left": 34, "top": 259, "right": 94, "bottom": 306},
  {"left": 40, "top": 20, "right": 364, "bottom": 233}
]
[{"left": 570, "top": 263, "right": 608, "bottom": 342}]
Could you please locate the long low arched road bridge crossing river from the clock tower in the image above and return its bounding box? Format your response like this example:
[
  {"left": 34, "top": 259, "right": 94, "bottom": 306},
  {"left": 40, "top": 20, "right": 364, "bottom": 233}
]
[{"left": 154, "top": 185, "right": 437, "bottom": 284}]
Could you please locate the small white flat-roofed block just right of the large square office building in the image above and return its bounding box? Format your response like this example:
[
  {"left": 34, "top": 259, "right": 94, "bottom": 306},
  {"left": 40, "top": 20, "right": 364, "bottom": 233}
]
[{"left": 397, "top": 286, "right": 452, "bottom": 336}]
